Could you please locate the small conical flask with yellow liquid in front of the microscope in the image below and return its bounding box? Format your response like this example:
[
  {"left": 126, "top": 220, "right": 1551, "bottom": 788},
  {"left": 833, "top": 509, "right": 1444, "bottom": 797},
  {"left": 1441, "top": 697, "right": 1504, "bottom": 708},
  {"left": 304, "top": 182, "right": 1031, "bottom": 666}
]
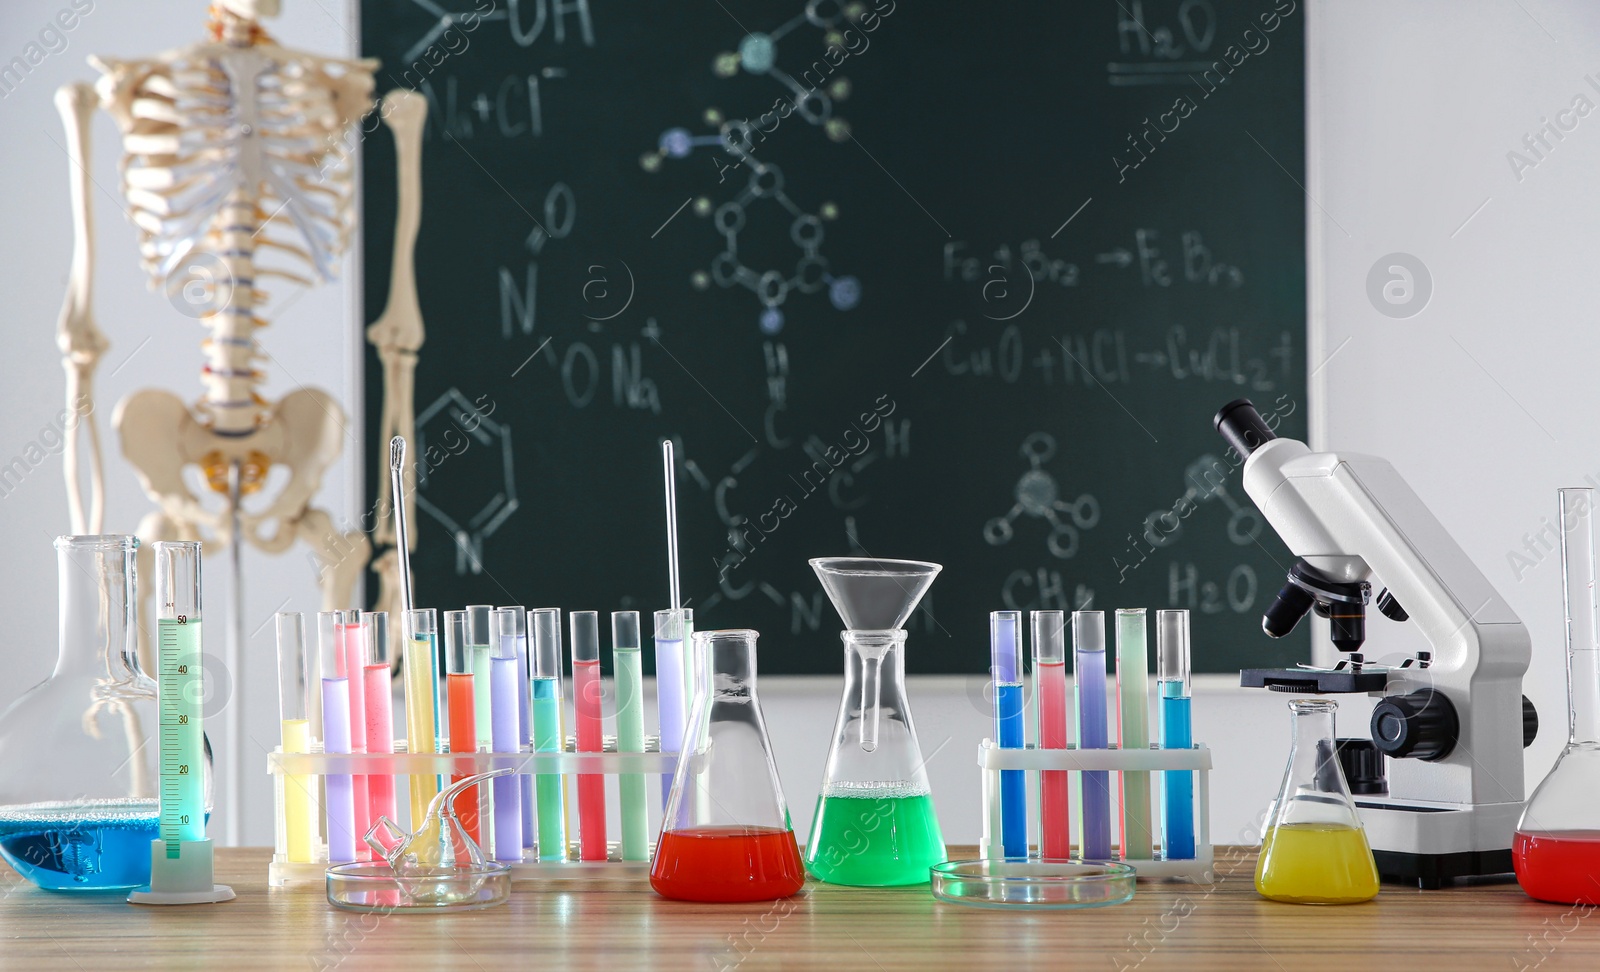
[{"left": 1256, "top": 699, "right": 1378, "bottom": 905}]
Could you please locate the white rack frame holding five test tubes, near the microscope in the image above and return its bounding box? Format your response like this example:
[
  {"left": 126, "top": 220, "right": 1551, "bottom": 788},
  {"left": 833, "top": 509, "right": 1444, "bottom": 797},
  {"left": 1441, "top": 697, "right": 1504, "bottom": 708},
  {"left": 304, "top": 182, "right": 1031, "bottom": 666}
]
[{"left": 978, "top": 739, "right": 1213, "bottom": 881}]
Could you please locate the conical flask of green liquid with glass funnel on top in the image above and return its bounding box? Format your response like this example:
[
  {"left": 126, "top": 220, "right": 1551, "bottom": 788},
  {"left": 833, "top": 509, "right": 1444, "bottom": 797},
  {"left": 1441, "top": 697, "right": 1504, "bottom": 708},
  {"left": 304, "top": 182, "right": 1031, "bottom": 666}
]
[{"left": 806, "top": 558, "right": 946, "bottom": 887}]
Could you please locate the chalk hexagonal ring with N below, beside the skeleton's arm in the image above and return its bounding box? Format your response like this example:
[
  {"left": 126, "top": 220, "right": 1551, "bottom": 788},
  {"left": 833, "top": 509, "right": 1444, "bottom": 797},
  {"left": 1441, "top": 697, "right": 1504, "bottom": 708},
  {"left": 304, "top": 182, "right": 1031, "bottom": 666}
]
[{"left": 416, "top": 388, "right": 518, "bottom": 576}]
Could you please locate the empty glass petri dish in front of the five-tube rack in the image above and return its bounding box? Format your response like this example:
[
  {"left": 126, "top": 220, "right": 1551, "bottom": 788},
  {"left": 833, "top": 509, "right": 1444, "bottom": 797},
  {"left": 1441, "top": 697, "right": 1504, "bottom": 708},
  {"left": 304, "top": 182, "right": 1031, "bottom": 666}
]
[{"left": 930, "top": 857, "right": 1136, "bottom": 911}]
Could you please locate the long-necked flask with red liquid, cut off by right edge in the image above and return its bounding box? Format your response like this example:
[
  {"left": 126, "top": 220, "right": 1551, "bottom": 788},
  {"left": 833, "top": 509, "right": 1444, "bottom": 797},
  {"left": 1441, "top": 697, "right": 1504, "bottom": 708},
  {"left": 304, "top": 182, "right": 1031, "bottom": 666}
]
[{"left": 1512, "top": 489, "right": 1600, "bottom": 905}]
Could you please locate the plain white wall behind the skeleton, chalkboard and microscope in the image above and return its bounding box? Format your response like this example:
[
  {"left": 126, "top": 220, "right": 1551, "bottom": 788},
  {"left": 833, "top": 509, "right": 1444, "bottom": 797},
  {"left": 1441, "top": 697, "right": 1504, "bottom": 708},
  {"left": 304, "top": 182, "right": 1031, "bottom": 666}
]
[{"left": 0, "top": 0, "right": 1600, "bottom": 844}]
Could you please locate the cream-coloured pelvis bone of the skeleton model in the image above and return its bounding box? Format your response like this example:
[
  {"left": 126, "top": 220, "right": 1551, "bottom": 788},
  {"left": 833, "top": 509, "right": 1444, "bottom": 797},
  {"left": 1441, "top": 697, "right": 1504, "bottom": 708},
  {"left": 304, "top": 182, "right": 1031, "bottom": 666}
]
[{"left": 112, "top": 388, "right": 344, "bottom": 521}]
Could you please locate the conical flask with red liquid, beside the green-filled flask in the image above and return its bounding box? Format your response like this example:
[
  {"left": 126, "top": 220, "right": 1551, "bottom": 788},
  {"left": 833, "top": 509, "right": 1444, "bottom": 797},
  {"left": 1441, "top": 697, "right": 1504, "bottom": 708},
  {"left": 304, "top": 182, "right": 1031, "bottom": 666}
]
[{"left": 650, "top": 630, "right": 805, "bottom": 902}]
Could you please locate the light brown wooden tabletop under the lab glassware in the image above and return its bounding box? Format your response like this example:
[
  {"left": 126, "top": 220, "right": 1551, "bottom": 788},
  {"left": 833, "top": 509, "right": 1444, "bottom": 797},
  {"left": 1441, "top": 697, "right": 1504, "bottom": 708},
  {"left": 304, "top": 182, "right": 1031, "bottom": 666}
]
[{"left": 0, "top": 847, "right": 1600, "bottom": 972}]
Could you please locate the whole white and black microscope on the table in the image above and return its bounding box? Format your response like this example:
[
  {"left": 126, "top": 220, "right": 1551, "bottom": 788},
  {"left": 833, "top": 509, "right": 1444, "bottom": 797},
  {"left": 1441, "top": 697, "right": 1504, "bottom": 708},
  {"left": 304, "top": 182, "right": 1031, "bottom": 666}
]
[{"left": 1214, "top": 398, "right": 1538, "bottom": 887}]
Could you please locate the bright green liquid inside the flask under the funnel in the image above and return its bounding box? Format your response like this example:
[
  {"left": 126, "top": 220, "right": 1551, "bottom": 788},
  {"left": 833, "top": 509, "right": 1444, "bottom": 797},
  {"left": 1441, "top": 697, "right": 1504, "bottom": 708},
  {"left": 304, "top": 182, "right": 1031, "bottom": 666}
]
[{"left": 806, "top": 783, "right": 946, "bottom": 887}]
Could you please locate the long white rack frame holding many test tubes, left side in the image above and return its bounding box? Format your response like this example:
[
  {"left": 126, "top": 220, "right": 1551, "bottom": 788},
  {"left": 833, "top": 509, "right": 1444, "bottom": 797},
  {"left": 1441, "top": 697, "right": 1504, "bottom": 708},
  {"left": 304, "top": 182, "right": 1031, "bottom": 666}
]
[{"left": 267, "top": 735, "right": 678, "bottom": 892}]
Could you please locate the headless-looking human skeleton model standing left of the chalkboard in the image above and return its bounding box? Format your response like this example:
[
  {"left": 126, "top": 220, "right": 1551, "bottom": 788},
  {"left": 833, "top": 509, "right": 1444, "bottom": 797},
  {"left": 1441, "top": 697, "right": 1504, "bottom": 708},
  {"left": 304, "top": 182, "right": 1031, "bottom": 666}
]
[{"left": 58, "top": 0, "right": 426, "bottom": 674}]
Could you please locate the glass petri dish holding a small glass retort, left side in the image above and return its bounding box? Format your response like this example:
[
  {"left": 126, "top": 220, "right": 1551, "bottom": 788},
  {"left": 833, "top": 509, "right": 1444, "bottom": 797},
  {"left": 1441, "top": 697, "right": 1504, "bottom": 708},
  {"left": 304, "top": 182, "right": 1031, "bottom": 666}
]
[{"left": 328, "top": 860, "right": 510, "bottom": 914}]
